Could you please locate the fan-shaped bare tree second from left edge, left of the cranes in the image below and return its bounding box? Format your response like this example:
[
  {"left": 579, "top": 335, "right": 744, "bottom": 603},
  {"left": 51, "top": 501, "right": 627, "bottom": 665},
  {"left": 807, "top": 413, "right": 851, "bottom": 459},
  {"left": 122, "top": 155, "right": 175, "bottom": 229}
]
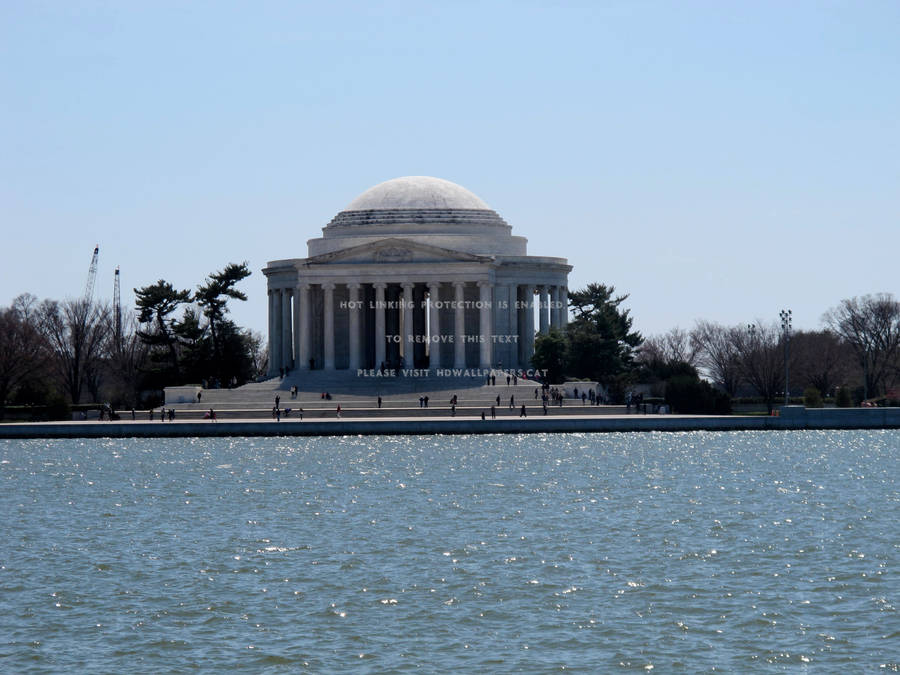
[{"left": 38, "top": 299, "right": 110, "bottom": 403}]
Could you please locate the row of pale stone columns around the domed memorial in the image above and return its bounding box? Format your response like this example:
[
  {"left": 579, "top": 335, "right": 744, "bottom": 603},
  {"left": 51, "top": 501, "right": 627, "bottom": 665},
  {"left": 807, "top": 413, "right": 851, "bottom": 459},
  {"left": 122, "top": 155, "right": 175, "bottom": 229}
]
[{"left": 269, "top": 280, "right": 568, "bottom": 376}]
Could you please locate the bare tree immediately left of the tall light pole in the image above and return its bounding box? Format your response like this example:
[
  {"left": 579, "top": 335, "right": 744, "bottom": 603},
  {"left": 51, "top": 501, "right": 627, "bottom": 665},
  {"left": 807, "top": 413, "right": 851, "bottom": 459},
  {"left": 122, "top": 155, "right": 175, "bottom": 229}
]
[{"left": 732, "top": 321, "right": 784, "bottom": 415}]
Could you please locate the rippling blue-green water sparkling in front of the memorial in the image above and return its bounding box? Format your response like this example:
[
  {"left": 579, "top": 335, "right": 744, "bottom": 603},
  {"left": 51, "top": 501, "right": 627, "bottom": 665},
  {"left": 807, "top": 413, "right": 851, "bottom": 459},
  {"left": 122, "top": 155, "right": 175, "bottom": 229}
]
[{"left": 0, "top": 431, "right": 900, "bottom": 673}]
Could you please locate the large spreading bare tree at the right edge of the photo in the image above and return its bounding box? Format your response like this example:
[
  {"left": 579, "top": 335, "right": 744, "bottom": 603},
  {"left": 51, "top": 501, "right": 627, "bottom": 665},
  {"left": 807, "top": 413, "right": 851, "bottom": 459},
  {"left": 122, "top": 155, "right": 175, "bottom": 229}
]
[{"left": 822, "top": 293, "right": 900, "bottom": 398}]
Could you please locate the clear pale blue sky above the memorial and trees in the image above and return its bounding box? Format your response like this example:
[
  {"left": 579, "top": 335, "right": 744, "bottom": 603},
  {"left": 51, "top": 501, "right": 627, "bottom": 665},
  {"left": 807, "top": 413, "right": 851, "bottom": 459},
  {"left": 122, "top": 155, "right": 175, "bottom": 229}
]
[{"left": 0, "top": 0, "right": 900, "bottom": 334}]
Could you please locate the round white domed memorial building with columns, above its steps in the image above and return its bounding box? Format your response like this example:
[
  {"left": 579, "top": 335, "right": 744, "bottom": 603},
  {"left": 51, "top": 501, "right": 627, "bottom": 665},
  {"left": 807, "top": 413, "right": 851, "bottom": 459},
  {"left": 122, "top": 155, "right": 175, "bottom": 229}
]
[{"left": 263, "top": 176, "right": 572, "bottom": 376}]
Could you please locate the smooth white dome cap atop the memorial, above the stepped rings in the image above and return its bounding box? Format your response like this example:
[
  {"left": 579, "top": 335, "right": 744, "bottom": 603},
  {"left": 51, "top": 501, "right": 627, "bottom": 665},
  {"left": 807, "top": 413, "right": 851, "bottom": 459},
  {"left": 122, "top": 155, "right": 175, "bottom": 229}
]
[{"left": 344, "top": 176, "right": 491, "bottom": 212}]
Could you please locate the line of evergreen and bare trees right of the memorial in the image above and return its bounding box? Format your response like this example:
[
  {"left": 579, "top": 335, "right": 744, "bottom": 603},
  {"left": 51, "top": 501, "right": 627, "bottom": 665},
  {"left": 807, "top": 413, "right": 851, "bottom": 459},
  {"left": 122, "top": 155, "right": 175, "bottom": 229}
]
[{"left": 533, "top": 284, "right": 900, "bottom": 412}]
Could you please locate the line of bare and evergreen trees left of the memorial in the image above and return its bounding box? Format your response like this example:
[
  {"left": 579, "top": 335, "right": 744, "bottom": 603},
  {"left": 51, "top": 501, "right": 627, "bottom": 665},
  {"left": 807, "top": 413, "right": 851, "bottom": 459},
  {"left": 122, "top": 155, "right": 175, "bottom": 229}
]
[{"left": 0, "top": 262, "right": 266, "bottom": 417}]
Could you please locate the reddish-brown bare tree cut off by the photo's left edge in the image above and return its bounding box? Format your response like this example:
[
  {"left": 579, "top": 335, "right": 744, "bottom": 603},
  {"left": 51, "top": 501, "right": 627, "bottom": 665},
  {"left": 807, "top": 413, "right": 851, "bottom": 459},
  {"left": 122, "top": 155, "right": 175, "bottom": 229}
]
[{"left": 0, "top": 294, "right": 47, "bottom": 415}]
